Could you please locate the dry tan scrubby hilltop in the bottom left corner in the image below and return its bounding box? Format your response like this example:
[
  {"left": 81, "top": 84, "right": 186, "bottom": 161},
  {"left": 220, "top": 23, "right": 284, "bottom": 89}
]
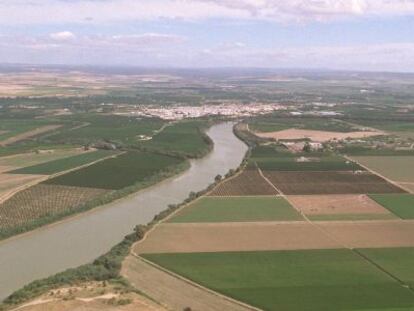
[{"left": 10, "top": 282, "right": 166, "bottom": 311}]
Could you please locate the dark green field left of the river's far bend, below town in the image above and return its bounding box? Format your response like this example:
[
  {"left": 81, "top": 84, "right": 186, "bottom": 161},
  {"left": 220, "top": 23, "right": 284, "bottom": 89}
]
[{"left": 142, "top": 121, "right": 210, "bottom": 157}]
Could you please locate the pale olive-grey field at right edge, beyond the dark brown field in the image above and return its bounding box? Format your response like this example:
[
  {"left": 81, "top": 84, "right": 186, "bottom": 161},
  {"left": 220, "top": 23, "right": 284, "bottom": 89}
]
[{"left": 353, "top": 156, "right": 414, "bottom": 182}]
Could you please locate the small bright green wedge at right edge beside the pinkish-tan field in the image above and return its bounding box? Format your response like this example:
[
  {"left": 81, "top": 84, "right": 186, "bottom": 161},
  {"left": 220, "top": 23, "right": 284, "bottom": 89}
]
[{"left": 370, "top": 194, "right": 414, "bottom": 219}]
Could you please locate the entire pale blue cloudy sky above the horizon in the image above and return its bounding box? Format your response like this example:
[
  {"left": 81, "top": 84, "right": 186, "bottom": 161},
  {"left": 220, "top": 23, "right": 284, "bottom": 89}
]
[{"left": 0, "top": 0, "right": 414, "bottom": 72}]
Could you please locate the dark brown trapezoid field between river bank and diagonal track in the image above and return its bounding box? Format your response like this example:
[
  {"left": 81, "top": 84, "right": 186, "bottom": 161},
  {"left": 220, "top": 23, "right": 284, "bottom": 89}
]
[{"left": 209, "top": 170, "right": 278, "bottom": 196}]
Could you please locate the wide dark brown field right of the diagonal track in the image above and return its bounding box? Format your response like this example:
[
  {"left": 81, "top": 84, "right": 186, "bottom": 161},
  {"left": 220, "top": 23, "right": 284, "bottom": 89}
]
[{"left": 263, "top": 171, "right": 405, "bottom": 195}]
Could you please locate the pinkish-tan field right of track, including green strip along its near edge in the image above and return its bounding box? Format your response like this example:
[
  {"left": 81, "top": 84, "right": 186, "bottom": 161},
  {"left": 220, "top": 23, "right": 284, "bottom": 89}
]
[{"left": 288, "top": 194, "right": 397, "bottom": 220}]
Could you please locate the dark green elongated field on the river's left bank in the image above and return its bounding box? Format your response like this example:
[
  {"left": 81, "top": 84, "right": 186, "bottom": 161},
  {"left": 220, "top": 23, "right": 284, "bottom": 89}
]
[{"left": 45, "top": 152, "right": 183, "bottom": 190}]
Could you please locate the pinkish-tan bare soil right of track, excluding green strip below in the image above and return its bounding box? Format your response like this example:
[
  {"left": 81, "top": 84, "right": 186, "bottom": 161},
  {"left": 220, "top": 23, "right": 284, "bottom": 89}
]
[{"left": 288, "top": 194, "right": 391, "bottom": 215}]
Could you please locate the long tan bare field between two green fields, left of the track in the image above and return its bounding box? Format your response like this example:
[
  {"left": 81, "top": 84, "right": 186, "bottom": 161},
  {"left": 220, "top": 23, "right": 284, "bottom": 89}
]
[{"left": 134, "top": 221, "right": 341, "bottom": 254}]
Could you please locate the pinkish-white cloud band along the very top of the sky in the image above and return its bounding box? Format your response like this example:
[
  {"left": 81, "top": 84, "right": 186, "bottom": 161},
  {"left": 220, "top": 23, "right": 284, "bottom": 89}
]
[{"left": 0, "top": 0, "right": 414, "bottom": 25}]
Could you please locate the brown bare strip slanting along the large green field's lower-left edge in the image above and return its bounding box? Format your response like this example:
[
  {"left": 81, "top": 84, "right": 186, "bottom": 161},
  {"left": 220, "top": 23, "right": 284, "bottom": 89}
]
[{"left": 121, "top": 255, "right": 250, "bottom": 311}]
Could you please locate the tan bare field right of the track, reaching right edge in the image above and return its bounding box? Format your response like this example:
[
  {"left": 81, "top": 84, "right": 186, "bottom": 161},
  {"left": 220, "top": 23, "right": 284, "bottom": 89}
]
[{"left": 318, "top": 220, "right": 414, "bottom": 248}]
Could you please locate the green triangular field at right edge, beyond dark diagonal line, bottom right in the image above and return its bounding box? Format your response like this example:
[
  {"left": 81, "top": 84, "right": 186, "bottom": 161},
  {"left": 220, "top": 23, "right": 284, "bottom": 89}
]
[{"left": 359, "top": 247, "right": 414, "bottom": 287}]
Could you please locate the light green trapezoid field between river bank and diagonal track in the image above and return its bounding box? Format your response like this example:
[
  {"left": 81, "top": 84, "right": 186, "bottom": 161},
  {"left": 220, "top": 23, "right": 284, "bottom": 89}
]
[{"left": 169, "top": 197, "right": 302, "bottom": 223}]
